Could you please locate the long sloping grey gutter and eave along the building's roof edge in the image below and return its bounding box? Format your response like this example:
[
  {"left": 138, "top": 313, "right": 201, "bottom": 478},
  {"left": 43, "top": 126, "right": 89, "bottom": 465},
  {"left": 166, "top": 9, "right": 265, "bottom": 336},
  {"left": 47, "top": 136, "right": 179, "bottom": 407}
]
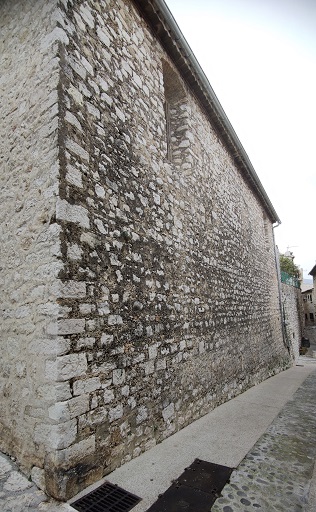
[{"left": 133, "top": 0, "right": 281, "bottom": 224}]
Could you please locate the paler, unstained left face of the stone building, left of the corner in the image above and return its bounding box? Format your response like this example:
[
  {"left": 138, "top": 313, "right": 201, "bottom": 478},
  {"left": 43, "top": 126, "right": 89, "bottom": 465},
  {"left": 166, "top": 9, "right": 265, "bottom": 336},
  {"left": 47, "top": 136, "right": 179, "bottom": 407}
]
[{"left": 0, "top": 0, "right": 62, "bottom": 467}]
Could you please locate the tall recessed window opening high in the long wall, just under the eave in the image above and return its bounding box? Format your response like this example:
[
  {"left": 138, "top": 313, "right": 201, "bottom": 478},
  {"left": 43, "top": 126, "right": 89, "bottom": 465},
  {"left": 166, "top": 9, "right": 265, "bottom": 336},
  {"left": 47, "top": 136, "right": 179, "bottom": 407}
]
[{"left": 162, "top": 60, "right": 188, "bottom": 163}]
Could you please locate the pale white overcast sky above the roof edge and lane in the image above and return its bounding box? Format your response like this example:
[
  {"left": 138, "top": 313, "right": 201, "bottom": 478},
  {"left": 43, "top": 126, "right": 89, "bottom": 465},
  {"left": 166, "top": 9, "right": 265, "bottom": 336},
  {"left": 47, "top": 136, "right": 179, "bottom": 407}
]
[{"left": 166, "top": 0, "right": 316, "bottom": 278}]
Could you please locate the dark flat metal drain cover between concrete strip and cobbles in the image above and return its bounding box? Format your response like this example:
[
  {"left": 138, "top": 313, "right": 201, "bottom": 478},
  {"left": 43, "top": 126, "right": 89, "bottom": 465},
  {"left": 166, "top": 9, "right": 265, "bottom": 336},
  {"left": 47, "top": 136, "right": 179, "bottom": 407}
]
[{"left": 147, "top": 459, "right": 233, "bottom": 512}]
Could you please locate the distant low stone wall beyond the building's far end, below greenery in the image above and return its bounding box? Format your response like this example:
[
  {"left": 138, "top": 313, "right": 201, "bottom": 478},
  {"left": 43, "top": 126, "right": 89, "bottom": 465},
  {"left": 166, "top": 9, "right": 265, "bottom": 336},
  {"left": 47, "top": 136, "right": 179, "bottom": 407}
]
[{"left": 281, "top": 283, "right": 305, "bottom": 361}]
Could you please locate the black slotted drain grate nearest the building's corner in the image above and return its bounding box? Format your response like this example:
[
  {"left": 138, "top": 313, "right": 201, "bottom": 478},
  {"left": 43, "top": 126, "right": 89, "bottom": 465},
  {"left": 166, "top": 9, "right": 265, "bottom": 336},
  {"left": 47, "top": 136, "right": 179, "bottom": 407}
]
[{"left": 71, "top": 482, "right": 141, "bottom": 512}]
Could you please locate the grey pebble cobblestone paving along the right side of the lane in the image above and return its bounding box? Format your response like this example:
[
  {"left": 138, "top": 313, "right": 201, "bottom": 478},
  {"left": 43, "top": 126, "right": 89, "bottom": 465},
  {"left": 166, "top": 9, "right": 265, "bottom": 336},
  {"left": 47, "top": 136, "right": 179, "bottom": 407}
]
[{"left": 212, "top": 366, "right": 316, "bottom": 512}]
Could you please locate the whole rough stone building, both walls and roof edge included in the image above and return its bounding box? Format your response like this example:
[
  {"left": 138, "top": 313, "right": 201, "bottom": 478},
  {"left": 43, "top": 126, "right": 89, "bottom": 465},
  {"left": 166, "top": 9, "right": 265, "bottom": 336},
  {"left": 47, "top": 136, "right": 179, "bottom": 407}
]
[{"left": 0, "top": 0, "right": 291, "bottom": 500}]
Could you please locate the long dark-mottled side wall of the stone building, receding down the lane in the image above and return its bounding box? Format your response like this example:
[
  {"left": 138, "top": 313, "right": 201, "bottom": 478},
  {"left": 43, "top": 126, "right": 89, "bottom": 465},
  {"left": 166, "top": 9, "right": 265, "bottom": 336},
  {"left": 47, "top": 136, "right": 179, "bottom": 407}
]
[{"left": 51, "top": 1, "right": 289, "bottom": 495}]
